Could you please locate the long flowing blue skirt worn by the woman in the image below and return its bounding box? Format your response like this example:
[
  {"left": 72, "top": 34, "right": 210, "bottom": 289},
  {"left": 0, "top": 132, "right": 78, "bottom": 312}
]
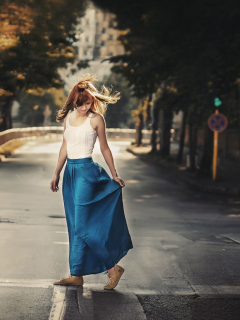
[{"left": 62, "top": 158, "right": 133, "bottom": 276}]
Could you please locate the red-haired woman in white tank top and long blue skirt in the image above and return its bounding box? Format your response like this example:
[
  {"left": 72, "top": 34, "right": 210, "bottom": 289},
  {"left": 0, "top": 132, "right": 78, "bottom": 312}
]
[{"left": 50, "top": 74, "right": 133, "bottom": 290}]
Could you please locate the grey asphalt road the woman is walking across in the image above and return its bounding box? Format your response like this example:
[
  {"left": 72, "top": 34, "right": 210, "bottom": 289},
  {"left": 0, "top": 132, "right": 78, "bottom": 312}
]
[{"left": 0, "top": 139, "right": 240, "bottom": 320}]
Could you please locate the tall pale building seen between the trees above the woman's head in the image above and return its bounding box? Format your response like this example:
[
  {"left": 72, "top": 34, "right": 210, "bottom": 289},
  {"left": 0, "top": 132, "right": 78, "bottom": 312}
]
[{"left": 59, "top": 1, "right": 124, "bottom": 92}]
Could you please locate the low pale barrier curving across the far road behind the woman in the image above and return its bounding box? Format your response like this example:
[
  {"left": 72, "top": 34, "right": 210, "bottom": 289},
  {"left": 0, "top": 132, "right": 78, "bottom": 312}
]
[{"left": 0, "top": 126, "right": 151, "bottom": 151}]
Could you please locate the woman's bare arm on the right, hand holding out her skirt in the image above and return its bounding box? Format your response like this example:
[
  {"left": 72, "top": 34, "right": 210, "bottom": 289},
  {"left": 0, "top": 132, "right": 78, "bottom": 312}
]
[{"left": 93, "top": 115, "right": 125, "bottom": 187}]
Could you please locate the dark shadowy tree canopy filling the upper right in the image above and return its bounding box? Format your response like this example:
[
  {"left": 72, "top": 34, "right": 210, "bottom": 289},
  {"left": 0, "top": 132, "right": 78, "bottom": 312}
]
[{"left": 94, "top": 0, "right": 240, "bottom": 125}]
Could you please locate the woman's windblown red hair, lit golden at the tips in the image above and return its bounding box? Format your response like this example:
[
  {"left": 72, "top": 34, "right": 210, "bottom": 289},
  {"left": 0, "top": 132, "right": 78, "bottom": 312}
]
[{"left": 56, "top": 73, "right": 120, "bottom": 122}]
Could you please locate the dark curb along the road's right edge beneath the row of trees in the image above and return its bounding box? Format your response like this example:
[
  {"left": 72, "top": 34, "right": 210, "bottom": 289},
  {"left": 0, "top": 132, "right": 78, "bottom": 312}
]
[{"left": 126, "top": 147, "right": 240, "bottom": 196}]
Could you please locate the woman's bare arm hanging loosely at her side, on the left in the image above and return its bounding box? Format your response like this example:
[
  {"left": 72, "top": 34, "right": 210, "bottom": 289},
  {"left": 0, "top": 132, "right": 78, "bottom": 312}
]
[{"left": 50, "top": 117, "right": 67, "bottom": 192}]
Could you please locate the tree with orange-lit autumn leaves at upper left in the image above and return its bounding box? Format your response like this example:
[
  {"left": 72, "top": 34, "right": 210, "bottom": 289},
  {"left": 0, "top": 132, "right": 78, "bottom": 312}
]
[{"left": 0, "top": 0, "right": 87, "bottom": 130}]
